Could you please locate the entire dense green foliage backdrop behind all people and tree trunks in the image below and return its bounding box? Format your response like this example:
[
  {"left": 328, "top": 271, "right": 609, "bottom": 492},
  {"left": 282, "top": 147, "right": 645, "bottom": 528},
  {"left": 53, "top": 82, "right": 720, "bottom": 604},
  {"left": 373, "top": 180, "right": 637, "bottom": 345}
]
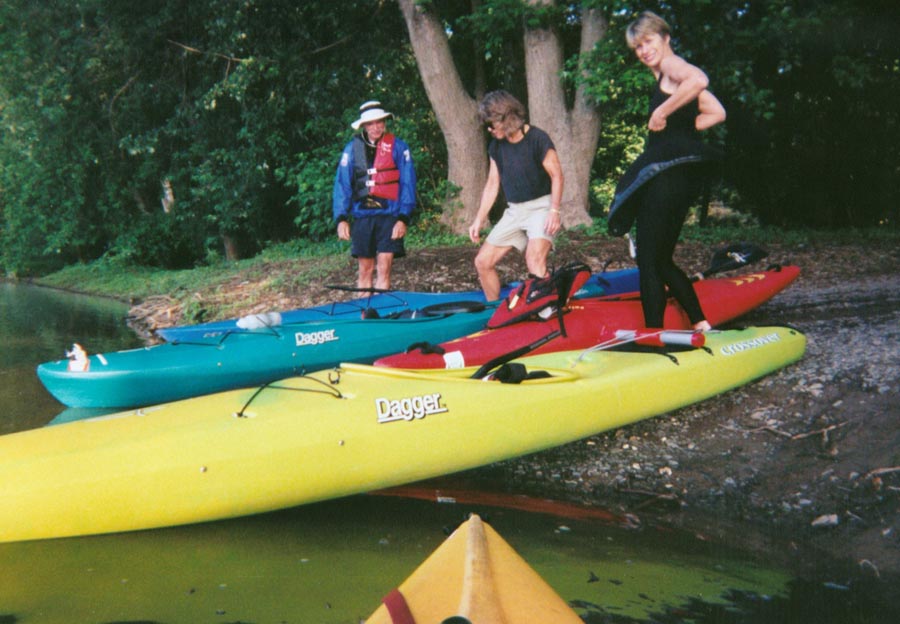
[{"left": 0, "top": 0, "right": 900, "bottom": 274}]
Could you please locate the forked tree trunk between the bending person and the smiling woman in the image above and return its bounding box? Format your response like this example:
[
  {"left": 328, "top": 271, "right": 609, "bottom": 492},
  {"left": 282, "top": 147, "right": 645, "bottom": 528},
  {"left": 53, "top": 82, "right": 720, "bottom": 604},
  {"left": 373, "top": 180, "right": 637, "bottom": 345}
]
[{"left": 525, "top": 0, "right": 607, "bottom": 228}]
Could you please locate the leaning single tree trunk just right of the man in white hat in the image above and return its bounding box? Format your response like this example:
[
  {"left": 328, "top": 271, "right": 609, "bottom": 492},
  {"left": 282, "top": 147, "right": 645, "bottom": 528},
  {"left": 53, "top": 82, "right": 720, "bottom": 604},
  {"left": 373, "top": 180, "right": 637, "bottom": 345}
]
[{"left": 397, "top": 0, "right": 488, "bottom": 234}]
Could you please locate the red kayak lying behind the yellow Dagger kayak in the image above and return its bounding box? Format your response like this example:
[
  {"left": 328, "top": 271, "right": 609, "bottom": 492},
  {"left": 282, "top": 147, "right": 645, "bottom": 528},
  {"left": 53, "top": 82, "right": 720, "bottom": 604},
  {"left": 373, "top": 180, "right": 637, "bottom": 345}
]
[{"left": 375, "top": 266, "right": 800, "bottom": 368}]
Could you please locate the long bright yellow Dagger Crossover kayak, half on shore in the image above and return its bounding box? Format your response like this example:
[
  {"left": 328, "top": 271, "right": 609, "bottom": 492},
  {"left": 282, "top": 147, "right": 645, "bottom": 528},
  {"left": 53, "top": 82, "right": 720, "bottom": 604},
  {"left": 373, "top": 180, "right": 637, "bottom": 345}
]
[{"left": 0, "top": 327, "right": 806, "bottom": 542}]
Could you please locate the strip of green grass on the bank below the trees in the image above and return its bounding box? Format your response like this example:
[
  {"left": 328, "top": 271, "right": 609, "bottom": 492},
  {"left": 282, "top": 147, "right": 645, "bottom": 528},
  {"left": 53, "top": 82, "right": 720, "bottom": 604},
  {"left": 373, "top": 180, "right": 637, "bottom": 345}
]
[{"left": 34, "top": 220, "right": 900, "bottom": 316}]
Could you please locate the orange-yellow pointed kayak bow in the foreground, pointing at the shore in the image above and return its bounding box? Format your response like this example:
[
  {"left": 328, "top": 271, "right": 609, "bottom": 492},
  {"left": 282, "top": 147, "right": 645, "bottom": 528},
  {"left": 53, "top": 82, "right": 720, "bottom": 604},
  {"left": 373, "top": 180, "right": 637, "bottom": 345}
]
[{"left": 366, "top": 515, "right": 583, "bottom": 624}]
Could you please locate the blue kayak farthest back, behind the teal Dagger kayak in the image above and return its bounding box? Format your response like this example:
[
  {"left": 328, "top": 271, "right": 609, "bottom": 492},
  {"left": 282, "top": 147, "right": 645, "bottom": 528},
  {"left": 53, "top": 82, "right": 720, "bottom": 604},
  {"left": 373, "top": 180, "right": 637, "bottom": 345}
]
[{"left": 155, "top": 269, "right": 640, "bottom": 342}]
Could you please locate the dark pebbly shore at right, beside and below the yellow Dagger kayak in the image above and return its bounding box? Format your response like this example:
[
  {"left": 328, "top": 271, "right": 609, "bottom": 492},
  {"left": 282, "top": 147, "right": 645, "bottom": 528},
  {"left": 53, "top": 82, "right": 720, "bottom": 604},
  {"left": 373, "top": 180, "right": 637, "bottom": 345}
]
[{"left": 493, "top": 281, "right": 900, "bottom": 582}]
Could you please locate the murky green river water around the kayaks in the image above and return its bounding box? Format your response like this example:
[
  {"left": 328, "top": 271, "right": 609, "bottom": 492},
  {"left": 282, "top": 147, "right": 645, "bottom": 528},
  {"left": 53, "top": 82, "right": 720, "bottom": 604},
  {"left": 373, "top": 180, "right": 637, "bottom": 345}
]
[{"left": 0, "top": 284, "right": 874, "bottom": 624}]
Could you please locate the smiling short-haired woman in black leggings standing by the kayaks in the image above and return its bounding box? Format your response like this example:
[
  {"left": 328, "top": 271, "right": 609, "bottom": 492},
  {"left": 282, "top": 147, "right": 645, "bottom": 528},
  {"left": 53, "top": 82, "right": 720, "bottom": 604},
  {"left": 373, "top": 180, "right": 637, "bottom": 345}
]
[{"left": 609, "top": 11, "right": 725, "bottom": 331}]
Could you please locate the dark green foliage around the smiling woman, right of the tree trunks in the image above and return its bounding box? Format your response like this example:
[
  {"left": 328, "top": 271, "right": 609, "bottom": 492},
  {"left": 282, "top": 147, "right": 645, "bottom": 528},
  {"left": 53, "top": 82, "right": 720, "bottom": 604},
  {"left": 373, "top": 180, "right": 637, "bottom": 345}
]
[{"left": 589, "top": 0, "right": 900, "bottom": 227}]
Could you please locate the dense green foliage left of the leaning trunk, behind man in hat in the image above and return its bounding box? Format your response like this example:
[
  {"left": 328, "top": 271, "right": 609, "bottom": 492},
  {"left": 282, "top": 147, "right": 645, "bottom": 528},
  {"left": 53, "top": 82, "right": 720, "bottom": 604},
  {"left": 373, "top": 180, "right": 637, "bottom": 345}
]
[{"left": 0, "top": 0, "right": 440, "bottom": 271}]
